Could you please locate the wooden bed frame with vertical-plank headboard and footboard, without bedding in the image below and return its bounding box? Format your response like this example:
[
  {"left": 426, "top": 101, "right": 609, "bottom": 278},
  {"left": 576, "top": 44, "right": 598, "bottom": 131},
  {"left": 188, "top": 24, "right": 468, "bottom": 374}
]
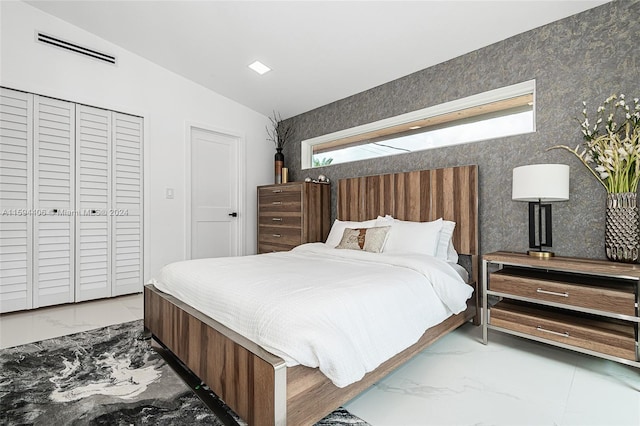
[{"left": 144, "top": 166, "right": 480, "bottom": 426}]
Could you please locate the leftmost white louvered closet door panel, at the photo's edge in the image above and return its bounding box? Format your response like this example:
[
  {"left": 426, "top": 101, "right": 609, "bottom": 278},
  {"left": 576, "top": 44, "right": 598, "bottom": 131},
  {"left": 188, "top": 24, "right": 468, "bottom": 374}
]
[{"left": 0, "top": 88, "right": 33, "bottom": 312}]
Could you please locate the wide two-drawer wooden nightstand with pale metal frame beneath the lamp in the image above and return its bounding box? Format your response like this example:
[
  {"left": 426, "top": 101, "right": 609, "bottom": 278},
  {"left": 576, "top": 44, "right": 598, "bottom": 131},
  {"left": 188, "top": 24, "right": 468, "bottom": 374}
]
[{"left": 482, "top": 252, "right": 640, "bottom": 367}]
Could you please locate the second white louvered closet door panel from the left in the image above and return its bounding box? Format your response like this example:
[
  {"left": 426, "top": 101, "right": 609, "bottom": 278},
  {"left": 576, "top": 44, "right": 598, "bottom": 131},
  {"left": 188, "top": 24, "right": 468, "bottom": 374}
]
[{"left": 33, "top": 96, "right": 75, "bottom": 308}]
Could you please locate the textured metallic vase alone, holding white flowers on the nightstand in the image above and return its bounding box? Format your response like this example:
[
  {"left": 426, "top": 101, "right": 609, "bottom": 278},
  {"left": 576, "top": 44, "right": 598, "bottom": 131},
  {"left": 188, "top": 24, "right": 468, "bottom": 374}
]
[{"left": 604, "top": 192, "right": 640, "bottom": 263}]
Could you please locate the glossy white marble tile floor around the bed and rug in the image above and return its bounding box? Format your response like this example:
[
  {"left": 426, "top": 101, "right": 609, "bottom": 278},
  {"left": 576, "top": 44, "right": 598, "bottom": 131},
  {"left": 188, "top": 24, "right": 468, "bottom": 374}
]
[{"left": 0, "top": 295, "right": 640, "bottom": 426}]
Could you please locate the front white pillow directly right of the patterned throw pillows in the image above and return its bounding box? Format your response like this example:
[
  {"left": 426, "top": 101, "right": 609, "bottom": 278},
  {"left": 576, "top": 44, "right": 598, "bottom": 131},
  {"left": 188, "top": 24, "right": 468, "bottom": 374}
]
[{"left": 376, "top": 218, "right": 442, "bottom": 256}]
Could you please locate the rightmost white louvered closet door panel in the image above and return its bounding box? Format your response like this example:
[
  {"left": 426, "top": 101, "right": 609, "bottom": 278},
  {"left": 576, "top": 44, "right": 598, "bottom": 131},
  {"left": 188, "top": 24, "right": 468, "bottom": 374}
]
[{"left": 112, "top": 112, "right": 143, "bottom": 296}]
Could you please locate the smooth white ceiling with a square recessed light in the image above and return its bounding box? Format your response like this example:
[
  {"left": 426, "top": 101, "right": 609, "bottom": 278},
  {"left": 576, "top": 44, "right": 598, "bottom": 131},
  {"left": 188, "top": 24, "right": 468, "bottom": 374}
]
[{"left": 27, "top": 0, "right": 609, "bottom": 118}]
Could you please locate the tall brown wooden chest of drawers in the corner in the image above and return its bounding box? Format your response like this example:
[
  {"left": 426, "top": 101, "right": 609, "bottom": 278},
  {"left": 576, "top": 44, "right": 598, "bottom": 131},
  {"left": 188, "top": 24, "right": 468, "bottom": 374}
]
[{"left": 258, "top": 182, "right": 331, "bottom": 253}]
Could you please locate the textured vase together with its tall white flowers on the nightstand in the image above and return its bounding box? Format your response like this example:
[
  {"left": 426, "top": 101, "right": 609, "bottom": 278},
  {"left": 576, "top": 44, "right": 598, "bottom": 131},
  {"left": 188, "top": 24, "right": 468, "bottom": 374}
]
[{"left": 549, "top": 94, "right": 640, "bottom": 263}]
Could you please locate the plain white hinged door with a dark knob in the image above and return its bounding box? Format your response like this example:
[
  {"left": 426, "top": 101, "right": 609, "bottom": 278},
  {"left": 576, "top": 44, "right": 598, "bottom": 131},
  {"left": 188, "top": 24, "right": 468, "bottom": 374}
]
[{"left": 191, "top": 127, "right": 239, "bottom": 259}]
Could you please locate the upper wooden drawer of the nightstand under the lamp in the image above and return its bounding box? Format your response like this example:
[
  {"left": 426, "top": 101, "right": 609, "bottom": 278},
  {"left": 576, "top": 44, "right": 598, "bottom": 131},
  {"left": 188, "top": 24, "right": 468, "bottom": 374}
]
[{"left": 489, "top": 269, "right": 636, "bottom": 316}]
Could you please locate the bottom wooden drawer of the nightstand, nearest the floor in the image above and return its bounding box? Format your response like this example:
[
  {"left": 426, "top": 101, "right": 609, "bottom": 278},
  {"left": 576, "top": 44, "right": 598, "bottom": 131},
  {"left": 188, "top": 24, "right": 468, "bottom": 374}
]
[{"left": 489, "top": 301, "right": 637, "bottom": 361}]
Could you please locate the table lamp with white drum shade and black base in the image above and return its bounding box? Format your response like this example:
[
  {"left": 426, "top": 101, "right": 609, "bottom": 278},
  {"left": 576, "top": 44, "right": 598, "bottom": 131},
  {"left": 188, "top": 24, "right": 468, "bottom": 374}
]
[{"left": 511, "top": 164, "right": 569, "bottom": 258}]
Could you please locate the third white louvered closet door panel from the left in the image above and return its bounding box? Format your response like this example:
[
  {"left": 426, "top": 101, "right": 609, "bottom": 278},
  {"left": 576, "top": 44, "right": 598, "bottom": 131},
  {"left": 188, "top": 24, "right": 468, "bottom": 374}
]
[{"left": 75, "top": 105, "right": 111, "bottom": 302}]
